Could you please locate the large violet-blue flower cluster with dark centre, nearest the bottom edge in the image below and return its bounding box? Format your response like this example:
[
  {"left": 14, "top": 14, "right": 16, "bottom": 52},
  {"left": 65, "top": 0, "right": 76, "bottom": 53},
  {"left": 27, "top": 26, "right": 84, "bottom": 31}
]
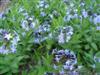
[{"left": 49, "top": 49, "right": 80, "bottom": 75}]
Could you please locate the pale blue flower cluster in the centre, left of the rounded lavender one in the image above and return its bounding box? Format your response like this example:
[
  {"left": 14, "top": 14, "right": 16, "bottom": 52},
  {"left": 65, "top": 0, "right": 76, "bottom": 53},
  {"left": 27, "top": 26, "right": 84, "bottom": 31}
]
[{"left": 34, "top": 22, "right": 50, "bottom": 43}]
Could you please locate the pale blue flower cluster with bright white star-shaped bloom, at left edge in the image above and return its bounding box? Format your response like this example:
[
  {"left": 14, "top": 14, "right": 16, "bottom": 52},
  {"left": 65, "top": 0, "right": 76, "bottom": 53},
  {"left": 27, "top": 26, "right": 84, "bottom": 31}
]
[{"left": 0, "top": 29, "right": 20, "bottom": 54}]
